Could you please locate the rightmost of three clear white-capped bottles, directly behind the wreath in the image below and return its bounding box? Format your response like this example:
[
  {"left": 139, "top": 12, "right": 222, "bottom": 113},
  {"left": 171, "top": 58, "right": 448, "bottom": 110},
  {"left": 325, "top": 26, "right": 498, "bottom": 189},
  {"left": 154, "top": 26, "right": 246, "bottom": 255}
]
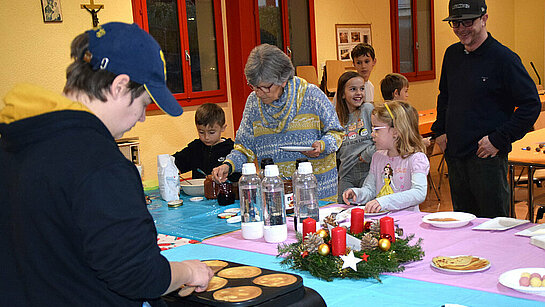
[{"left": 295, "top": 162, "right": 320, "bottom": 232}]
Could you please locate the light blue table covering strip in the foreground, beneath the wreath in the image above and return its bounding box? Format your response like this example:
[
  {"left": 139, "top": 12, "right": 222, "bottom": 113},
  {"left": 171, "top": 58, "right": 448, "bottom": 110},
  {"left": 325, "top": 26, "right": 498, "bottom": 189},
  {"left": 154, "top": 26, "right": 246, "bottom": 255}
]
[{"left": 163, "top": 244, "right": 543, "bottom": 307}]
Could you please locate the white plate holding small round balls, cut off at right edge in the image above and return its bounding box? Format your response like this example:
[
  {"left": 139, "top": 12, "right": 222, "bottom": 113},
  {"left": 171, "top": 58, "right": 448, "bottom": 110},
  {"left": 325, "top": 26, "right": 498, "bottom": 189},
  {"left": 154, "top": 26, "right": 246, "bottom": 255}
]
[{"left": 498, "top": 268, "right": 545, "bottom": 296}]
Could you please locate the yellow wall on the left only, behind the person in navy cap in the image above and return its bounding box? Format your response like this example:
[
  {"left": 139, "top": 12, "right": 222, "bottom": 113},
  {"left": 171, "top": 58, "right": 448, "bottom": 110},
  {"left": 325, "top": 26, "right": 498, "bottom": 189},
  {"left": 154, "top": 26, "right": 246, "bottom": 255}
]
[{"left": 0, "top": 0, "right": 234, "bottom": 179}]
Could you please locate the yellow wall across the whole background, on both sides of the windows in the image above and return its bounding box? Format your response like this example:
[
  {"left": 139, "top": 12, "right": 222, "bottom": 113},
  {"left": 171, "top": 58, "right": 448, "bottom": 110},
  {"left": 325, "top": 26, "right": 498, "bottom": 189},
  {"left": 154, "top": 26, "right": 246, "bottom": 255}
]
[{"left": 0, "top": 0, "right": 545, "bottom": 179}]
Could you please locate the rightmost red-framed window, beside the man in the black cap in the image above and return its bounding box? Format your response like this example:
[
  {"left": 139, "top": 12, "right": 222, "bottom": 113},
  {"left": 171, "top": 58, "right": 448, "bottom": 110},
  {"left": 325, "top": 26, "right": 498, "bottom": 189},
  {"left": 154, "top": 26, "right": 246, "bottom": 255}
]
[{"left": 390, "top": 0, "right": 435, "bottom": 81}]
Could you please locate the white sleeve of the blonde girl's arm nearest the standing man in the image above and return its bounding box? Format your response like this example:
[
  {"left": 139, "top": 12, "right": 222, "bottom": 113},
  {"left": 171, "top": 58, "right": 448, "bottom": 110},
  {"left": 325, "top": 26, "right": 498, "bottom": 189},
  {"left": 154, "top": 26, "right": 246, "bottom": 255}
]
[{"left": 376, "top": 173, "right": 428, "bottom": 210}]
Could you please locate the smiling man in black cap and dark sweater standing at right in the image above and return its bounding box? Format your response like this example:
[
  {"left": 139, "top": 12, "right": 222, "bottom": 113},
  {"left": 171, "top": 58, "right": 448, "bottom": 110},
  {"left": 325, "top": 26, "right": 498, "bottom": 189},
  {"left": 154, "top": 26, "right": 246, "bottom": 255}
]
[{"left": 432, "top": 0, "right": 541, "bottom": 218}]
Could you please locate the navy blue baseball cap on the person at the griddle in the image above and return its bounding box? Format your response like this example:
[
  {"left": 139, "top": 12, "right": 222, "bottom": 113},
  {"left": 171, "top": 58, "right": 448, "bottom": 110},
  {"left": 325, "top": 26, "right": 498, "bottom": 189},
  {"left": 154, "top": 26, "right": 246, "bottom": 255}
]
[{"left": 87, "top": 22, "right": 183, "bottom": 116}]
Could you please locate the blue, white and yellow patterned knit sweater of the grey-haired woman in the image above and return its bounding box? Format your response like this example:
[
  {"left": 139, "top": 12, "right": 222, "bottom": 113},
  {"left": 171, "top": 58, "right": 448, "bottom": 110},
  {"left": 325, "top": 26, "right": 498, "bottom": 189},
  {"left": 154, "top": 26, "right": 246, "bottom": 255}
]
[{"left": 226, "top": 77, "right": 343, "bottom": 201}]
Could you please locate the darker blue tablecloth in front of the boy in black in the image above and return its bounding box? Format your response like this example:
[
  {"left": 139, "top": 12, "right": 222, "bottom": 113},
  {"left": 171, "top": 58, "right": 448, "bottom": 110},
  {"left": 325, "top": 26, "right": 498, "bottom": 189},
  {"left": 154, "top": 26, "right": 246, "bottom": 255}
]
[{"left": 145, "top": 190, "right": 329, "bottom": 241}]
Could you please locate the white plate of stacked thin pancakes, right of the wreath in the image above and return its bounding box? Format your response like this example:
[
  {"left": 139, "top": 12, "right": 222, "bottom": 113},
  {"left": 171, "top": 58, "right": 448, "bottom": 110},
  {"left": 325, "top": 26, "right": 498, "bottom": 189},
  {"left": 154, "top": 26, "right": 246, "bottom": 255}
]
[{"left": 431, "top": 255, "right": 490, "bottom": 273}]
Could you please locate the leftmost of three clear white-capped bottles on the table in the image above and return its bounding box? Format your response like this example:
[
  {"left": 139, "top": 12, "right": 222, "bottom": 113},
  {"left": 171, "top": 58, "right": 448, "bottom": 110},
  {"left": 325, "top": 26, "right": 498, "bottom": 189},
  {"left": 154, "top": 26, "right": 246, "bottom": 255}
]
[{"left": 238, "top": 163, "right": 263, "bottom": 239}]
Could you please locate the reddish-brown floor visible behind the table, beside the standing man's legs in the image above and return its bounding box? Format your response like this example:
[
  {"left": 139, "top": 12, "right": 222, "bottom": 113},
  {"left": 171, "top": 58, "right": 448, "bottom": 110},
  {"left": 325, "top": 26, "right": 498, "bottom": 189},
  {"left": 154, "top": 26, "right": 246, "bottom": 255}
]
[{"left": 420, "top": 156, "right": 545, "bottom": 223}]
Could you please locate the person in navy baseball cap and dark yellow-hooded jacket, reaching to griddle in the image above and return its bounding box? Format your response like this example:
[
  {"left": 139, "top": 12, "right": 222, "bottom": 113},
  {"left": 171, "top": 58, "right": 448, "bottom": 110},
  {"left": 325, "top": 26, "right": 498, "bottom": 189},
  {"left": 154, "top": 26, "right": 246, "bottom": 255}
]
[{"left": 0, "top": 23, "right": 213, "bottom": 306}]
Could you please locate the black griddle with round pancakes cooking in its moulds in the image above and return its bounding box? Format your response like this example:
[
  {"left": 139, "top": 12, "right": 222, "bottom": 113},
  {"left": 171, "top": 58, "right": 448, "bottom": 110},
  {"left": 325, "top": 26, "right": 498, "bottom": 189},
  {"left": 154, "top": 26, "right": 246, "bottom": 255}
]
[{"left": 163, "top": 260, "right": 305, "bottom": 306}]
